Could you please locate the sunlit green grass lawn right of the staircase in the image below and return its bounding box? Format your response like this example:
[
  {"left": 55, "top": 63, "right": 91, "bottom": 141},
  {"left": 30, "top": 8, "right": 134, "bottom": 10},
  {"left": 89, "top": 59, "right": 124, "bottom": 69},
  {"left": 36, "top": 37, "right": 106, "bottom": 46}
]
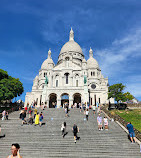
[{"left": 115, "top": 109, "right": 141, "bottom": 132}]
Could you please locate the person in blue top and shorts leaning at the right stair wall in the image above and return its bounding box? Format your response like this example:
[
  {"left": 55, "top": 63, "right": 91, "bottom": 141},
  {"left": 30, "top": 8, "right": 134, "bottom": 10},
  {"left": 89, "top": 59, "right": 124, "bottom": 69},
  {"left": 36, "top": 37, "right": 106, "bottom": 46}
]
[{"left": 127, "top": 122, "right": 136, "bottom": 143}]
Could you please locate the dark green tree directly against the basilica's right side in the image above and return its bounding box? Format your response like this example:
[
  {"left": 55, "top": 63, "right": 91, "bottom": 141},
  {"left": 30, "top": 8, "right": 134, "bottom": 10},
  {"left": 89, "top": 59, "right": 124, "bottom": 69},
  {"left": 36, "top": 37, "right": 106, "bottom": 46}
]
[{"left": 108, "top": 83, "right": 126, "bottom": 102}]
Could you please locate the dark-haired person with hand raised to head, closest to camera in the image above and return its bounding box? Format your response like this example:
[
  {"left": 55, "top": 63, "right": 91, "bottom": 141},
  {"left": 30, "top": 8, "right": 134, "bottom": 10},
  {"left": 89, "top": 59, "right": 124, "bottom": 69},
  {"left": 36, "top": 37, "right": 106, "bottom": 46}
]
[{"left": 7, "top": 143, "right": 22, "bottom": 158}]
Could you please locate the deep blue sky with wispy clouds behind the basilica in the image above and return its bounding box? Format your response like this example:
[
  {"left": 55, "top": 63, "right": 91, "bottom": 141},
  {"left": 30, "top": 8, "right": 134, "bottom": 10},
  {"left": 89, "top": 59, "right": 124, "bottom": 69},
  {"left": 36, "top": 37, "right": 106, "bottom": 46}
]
[{"left": 0, "top": 0, "right": 141, "bottom": 100}]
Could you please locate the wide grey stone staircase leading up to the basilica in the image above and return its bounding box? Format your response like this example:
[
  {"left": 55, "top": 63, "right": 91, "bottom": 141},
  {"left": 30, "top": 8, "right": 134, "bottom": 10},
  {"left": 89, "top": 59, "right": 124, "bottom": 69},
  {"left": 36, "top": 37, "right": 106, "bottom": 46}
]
[{"left": 0, "top": 109, "right": 141, "bottom": 158}]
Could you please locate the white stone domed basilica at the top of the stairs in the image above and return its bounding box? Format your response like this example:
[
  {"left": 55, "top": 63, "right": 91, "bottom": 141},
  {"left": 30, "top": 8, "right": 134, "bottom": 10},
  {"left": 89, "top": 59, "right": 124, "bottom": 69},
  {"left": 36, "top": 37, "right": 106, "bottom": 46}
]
[{"left": 25, "top": 29, "right": 108, "bottom": 107}]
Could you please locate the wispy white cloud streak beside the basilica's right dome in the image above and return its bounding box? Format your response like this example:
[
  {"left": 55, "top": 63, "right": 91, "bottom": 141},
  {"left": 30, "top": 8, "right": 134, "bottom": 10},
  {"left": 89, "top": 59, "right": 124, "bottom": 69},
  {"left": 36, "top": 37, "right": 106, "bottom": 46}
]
[{"left": 96, "top": 28, "right": 141, "bottom": 76}]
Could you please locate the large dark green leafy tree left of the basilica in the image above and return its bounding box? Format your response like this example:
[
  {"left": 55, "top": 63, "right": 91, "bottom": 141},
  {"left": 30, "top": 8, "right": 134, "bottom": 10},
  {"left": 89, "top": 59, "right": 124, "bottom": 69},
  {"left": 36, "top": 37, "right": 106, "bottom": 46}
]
[{"left": 0, "top": 69, "right": 24, "bottom": 102}]
